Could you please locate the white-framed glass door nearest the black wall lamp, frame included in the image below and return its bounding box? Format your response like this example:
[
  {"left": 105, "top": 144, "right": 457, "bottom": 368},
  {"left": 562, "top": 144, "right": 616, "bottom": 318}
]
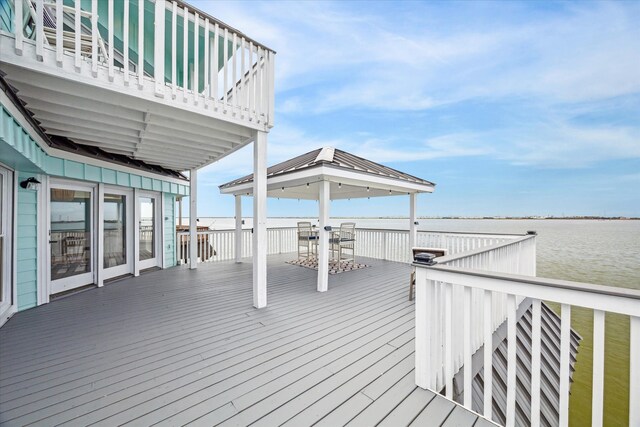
[{"left": 49, "top": 182, "right": 95, "bottom": 294}]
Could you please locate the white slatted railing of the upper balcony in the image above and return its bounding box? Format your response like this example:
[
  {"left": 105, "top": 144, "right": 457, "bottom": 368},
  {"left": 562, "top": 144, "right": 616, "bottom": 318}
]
[{"left": 5, "top": 0, "right": 275, "bottom": 126}]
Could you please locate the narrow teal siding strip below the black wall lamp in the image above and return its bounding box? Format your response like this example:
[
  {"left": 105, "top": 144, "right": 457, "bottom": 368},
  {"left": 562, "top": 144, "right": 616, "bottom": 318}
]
[{"left": 16, "top": 174, "right": 38, "bottom": 310}]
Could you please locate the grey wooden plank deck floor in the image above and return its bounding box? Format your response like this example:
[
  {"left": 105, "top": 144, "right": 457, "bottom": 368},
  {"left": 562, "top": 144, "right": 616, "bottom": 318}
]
[{"left": 0, "top": 255, "right": 493, "bottom": 427}]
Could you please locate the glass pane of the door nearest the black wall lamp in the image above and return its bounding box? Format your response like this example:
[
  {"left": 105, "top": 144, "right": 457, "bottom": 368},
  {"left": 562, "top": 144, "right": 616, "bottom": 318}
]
[{"left": 49, "top": 188, "right": 91, "bottom": 280}]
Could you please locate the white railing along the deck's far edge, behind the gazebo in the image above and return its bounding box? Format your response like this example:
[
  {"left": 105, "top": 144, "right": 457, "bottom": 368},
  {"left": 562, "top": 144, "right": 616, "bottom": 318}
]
[{"left": 176, "top": 227, "right": 522, "bottom": 263}]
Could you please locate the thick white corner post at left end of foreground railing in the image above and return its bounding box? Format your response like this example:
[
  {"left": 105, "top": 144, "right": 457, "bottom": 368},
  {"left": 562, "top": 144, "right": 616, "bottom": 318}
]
[{"left": 415, "top": 267, "right": 434, "bottom": 389}]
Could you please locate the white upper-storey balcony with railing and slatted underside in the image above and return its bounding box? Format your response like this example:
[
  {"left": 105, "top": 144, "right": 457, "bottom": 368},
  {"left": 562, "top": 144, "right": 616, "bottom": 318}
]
[{"left": 0, "top": 0, "right": 275, "bottom": 170}]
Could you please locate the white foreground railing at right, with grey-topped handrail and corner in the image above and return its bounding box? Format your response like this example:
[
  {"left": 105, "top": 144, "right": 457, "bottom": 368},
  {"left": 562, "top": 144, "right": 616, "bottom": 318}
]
[{"left": 415, "top": 247, "right": 640, "bottom": 426}]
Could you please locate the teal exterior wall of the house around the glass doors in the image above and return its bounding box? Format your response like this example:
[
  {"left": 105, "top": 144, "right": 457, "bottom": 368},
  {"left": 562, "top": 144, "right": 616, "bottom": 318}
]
[{"left": 0, "top": 103, "right": 189, "bottom": 310}]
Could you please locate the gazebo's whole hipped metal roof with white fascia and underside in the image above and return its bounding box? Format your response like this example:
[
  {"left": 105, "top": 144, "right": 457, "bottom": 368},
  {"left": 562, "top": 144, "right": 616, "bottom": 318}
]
[{"left": 220, "top": 147, "right": 435, "bottom": 200}]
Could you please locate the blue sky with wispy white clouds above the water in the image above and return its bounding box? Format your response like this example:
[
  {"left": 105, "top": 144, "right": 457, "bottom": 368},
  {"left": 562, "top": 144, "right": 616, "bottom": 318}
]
[{"left": 191, "top": 0, "right": 640, "bottom": 217}]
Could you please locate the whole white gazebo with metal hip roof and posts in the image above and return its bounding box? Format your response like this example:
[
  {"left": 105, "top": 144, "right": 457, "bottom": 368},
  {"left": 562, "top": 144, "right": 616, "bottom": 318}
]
[{"left": 220, "top": 147, "right": 435, "bottom": 306}]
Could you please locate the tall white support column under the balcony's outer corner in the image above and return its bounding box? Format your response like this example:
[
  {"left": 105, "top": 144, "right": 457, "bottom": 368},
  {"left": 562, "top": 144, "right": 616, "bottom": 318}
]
[{"left": 252, "top": 132, "right": 267, "bottom": 308}]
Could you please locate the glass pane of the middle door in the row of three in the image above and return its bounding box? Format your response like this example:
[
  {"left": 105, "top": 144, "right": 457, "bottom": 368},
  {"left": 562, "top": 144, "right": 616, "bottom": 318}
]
[{"left": 103, "top": 194, "right": 127, "bottom": 268}]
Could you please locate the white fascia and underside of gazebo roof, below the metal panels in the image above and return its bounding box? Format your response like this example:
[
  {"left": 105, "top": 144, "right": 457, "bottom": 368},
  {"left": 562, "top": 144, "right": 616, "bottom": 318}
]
[{"left": 220, "top": 164, "right": 435, "bottom": 200}]
